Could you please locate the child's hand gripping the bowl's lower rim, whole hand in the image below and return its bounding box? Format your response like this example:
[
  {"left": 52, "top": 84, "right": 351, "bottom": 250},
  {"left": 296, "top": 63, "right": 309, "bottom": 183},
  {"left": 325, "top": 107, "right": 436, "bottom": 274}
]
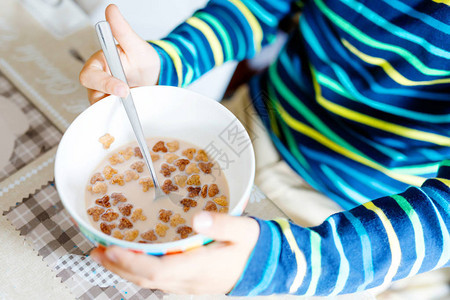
[{"left": 91, "top": 212, "right": 259, "bottom": 294}]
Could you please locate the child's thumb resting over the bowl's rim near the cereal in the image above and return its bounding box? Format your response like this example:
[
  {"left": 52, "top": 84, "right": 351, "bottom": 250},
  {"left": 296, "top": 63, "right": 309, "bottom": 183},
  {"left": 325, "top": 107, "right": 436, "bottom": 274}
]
[{"left": 193, "top": 211, "right": 245, "bottom": 241}]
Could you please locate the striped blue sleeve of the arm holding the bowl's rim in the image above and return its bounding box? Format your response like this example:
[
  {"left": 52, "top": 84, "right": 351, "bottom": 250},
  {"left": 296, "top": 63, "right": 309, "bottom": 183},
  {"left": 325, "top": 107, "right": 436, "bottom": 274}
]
[{"left": 230, "top": 160, "right": 450, "bottom": 296}]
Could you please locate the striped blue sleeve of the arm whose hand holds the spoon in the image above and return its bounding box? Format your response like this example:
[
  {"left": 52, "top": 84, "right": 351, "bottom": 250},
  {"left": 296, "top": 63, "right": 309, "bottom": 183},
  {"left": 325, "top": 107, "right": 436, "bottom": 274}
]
[{"left": 150, "top": 0, "right": 301, "bottom": 87}]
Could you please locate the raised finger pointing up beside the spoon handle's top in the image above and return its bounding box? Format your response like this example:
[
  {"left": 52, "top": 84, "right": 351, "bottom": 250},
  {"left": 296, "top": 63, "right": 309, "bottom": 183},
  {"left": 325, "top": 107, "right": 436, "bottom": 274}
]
[{"left": 105, "top": 4, "right": 142, "bottom": 53}]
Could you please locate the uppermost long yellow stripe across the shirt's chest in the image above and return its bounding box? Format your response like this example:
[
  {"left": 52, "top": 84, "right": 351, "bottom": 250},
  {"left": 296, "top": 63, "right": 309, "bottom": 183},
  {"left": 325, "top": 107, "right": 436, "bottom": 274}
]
[{"left": 342, "top": 39, "right": 450, "bottom": 86}]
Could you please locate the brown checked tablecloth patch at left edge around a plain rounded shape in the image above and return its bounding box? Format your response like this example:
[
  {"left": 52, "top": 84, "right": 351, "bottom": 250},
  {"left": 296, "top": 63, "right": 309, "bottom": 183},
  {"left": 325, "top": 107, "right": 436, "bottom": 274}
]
[{"left": 0, "top": 73, "right": 62, "bottom": 181}]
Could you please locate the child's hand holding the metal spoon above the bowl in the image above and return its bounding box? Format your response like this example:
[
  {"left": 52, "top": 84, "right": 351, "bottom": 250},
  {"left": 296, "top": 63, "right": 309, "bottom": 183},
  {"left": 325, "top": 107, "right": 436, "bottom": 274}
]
[{"left": 80, "top": 4, "right": 161, "bottom": 104}]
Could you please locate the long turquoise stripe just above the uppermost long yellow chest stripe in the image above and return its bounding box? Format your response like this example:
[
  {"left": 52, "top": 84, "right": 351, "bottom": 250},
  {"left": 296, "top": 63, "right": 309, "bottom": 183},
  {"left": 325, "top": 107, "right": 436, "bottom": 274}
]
[{"left": 315, "top": 0, "right": 450, "bottom": 76}]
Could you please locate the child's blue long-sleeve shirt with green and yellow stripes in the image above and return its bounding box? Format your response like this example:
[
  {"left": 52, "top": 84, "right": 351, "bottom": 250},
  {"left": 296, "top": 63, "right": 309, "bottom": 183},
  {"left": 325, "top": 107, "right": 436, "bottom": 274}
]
[{"left": 152, "top": 0, "right": 450, "bottom": 295}]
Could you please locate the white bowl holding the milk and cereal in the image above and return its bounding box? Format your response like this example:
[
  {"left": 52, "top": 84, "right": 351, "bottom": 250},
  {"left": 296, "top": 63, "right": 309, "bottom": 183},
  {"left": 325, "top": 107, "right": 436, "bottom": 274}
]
[{"left": 55, "top": 86, "right": 255, "bottom": 255}]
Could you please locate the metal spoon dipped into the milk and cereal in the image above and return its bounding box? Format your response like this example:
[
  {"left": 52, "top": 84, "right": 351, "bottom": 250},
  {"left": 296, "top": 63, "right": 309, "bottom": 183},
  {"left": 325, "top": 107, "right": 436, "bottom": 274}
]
[{"left": 95, "top": 21, "right": 168, "bottom": 201}]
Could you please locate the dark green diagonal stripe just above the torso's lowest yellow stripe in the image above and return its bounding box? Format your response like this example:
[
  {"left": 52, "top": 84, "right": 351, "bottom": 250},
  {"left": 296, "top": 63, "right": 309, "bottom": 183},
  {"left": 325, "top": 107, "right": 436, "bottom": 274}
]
[{"left": 269, "top": 63, "right": 372, "bottom": 161}]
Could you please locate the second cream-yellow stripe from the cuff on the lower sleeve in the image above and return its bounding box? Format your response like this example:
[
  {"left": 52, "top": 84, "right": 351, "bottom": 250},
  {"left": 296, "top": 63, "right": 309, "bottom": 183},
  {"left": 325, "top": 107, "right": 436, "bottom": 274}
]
[{"left": 363, "top": 202, "right": 402, "bottom": 286}]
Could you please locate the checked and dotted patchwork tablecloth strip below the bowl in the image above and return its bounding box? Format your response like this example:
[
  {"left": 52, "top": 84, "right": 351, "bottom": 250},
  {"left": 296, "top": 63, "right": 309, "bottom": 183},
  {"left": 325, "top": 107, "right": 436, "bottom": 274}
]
[{"left": 4, "top": 183, "right": 283, "bottom": 299}]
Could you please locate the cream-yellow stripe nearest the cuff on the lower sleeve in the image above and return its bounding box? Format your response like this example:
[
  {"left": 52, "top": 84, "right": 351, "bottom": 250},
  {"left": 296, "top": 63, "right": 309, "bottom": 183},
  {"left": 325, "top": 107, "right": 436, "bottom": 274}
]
[{"left": 274, "top": 218, "right": 306, "bottom": 294}]
